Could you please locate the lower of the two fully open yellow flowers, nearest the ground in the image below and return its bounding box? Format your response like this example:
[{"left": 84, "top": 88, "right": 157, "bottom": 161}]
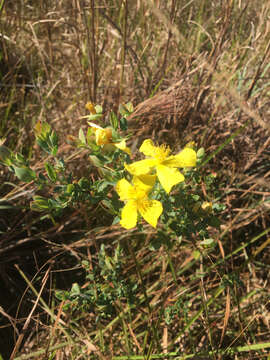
[{"left": 116, "top": 175, "right": 163, "bottom": 229}]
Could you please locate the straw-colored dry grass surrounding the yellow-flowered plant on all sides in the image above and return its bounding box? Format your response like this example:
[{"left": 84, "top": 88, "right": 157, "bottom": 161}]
[{"left": 0, "top": 0, "right": 270, "bottom": 360}]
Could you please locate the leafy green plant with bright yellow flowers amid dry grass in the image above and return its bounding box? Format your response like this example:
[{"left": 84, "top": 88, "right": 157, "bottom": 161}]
[{"left": 0, "top": 103, "right": 221, "bottom": 240}]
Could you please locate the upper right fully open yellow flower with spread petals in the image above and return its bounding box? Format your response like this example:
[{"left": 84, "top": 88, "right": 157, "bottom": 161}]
[{"left": 125, "top": 139, "right": 197, "bottom": 193}]
